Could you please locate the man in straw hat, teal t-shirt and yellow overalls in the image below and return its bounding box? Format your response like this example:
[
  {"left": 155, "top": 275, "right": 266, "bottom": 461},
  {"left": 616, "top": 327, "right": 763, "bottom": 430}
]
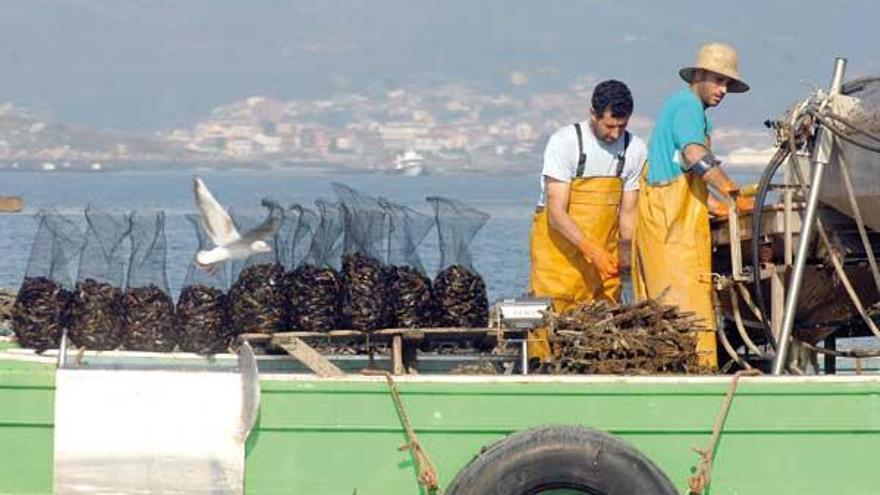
[{"left": 633, "top": 43, "right": 750, "bottom": 368}]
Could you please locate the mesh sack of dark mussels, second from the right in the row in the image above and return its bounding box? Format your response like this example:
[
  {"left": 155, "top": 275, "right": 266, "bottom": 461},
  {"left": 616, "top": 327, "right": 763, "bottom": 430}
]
[{"left": 379, "top": 198, "right": 434, "bottom": 328}]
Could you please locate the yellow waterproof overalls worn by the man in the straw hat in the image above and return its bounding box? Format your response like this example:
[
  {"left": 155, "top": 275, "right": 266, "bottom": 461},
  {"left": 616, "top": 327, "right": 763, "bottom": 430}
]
[{"left": 632, "top": 170, "right": 718, "bottom": 368}]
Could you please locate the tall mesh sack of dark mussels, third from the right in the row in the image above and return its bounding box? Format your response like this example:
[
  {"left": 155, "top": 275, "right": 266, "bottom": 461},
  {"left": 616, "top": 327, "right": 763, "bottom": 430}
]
[{"left": 333, "top": 183, "right": 388, "bottom": 331}]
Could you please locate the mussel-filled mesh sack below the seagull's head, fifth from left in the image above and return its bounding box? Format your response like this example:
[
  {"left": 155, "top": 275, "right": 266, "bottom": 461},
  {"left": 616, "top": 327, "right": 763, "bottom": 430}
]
[{"left": 227, "top": 200, "right": 288, "bottom": 335}]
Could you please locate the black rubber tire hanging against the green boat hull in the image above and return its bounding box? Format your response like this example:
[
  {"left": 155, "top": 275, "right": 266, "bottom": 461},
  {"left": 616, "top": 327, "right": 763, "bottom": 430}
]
[{"left": 445, "top": 426, "right": 679, "bottom": 495}]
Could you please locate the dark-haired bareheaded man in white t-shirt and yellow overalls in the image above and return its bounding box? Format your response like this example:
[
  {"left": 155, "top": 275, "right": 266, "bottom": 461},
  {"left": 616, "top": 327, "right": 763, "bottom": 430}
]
[{"left": 530, "top": 80, "right": 647, "bottom": 311}]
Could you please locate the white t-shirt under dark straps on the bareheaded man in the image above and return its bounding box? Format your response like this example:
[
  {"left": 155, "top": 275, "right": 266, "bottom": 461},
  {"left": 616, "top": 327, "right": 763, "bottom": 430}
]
[{"left": 538, "top": 121, "right": 648, "bottom": 206}]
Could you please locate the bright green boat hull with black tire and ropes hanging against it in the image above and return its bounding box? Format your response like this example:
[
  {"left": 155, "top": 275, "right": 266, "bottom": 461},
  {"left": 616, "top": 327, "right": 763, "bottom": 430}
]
[{"left": 0, "top": 358, "right": 880, "bottom": 495}]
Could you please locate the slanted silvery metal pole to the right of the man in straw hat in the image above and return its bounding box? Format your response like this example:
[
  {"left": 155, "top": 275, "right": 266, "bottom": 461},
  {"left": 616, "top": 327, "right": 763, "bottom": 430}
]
[{"left": 773, "top": 57, "right": 846, "bottom": 375}]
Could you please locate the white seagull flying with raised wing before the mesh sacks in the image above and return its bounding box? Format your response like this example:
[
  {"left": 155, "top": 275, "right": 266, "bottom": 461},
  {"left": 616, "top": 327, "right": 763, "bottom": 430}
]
[{"left": 193, "top": 177, "right": 281, "bottom": 267}]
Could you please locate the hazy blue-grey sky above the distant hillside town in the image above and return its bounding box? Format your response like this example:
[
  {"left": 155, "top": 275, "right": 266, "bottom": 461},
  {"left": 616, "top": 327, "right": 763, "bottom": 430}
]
[{"left": 0, "top": 0, "right": 880, "bottom": 130}]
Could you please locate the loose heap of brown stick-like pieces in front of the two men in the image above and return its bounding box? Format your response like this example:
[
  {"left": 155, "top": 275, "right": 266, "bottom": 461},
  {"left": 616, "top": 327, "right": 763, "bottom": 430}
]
[{"left": 544, "top": 300, "right": 711, "bottom": 375}]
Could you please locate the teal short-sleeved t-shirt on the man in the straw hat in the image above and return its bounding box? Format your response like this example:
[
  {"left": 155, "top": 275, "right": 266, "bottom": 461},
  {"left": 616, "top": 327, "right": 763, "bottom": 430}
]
[{"left": 648, "top": 89, "right": 712, "bottom": 184}]
